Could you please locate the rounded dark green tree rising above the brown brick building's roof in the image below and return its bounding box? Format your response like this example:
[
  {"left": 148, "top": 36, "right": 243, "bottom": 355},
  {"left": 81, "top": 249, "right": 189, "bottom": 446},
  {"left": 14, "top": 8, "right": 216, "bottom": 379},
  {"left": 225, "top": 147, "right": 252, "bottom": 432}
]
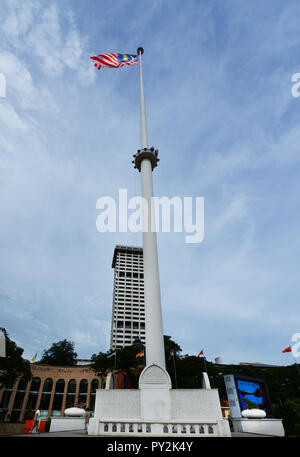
[{"left": 39, "top": 340, "right": 77, "bottom": 366}]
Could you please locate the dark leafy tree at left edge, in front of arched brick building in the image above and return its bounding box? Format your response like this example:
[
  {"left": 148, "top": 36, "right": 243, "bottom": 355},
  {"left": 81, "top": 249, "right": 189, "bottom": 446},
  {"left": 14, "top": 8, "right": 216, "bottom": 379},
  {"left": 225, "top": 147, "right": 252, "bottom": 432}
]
[{"left": 0, "top": 327, "right": 31, "bottom": 388}]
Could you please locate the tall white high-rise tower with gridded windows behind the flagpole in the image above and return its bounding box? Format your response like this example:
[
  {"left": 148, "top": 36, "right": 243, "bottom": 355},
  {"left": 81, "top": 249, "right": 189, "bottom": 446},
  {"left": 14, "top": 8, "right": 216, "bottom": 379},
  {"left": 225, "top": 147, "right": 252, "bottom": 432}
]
[{"left": 110, "top": 245, "right": 145, "bottom": 349}]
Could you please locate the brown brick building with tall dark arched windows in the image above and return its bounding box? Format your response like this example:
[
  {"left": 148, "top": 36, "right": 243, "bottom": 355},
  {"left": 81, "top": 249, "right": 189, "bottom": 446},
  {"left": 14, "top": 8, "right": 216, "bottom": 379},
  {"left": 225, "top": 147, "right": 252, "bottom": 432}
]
[{"left": 0, "top": 363, "right": 105, "bottom": 422}]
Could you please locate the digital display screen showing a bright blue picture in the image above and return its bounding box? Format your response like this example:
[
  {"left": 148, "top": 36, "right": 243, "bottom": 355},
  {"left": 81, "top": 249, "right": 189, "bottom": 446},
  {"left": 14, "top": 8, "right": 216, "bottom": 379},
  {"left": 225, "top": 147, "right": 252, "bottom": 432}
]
[{"left": 236, "top": 378, "right": 272, "bottom": 416}]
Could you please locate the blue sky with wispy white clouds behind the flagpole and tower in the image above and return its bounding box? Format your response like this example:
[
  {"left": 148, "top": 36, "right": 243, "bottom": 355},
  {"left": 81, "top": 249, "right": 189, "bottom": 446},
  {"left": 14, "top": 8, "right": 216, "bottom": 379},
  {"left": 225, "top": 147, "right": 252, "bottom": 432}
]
[{"left": 0, "top": 0, "right": 300, "bottom": 365}]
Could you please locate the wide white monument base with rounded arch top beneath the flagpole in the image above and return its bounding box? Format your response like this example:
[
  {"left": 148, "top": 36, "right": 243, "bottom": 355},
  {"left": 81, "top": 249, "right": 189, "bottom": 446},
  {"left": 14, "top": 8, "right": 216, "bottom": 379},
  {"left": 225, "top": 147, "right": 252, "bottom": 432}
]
[{"left": 88, "top": 364, "right": 231, "bottom": 437}]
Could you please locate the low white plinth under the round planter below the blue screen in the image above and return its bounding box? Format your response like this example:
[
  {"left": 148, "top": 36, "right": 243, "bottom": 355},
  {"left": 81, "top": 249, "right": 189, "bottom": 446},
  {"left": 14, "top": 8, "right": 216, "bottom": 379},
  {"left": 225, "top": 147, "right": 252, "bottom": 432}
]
[{"left": 232, "top": 418, "right": 285, "bottom": 436}]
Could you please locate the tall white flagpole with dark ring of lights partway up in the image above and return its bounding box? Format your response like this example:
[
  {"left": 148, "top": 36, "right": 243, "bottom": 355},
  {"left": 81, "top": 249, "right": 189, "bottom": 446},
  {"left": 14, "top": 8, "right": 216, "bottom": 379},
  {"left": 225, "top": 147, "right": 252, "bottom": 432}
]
[{"left": 133, "top": 48, "right": 166, "bottom": 368}]
